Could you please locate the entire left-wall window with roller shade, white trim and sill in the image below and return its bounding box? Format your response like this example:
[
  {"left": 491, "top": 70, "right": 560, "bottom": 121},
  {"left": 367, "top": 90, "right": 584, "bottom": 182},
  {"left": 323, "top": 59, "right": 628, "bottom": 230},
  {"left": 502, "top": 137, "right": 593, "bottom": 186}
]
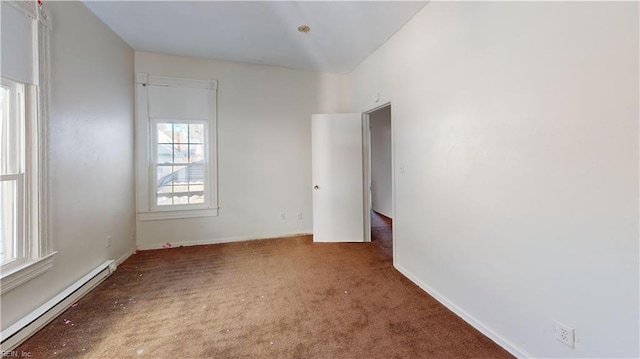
[{"left": 0, "top": 0, "right": 55, "bottom": 294}]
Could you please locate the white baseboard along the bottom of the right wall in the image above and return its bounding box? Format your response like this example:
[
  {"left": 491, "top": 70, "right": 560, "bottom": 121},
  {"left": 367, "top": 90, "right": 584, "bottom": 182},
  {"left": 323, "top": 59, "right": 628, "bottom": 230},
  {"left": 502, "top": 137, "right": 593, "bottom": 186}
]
[{"left": 393, "top": 263, "right": 532, "bottom": 358}]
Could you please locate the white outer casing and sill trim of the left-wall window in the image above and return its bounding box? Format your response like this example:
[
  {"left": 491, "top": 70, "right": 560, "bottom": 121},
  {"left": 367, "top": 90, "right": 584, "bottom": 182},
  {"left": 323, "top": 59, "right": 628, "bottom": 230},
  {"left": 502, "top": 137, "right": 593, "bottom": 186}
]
[{"left": 0, "top": 0, "right": 58, "bottom": 295}]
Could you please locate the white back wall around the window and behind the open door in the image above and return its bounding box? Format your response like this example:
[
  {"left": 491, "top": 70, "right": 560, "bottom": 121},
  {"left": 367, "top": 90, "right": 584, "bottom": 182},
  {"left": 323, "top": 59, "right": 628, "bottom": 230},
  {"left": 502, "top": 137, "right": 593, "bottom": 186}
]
[{"left": 135, "top": 52, "right": 350, "bottom": 249}]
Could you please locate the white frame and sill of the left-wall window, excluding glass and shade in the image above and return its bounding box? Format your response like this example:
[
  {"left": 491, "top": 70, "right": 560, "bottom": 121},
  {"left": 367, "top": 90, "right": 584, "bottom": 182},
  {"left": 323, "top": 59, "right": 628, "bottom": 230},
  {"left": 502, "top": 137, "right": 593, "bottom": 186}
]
[{"left": 0, "top": 0, "right": 57, "bottom": 295}]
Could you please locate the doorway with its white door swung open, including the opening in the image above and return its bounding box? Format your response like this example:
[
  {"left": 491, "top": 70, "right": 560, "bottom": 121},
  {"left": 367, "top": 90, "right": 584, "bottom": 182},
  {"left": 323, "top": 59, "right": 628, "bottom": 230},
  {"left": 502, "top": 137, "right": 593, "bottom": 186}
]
[{"left": 311, "top": 107, "right": 394, "bottom": 248}]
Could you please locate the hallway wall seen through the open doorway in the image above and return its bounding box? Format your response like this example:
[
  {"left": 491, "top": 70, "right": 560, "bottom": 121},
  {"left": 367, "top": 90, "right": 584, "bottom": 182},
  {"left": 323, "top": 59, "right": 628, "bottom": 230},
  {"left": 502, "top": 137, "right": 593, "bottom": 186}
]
[{"left": 369, "top": 106, "right": 393, "bottom": 218}]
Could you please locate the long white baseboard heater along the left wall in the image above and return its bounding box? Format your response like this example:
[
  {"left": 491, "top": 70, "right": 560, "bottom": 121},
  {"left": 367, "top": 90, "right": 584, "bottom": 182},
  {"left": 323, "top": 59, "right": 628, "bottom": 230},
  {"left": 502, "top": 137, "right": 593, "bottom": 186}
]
[{"left": 0, "top": 260, "right": 116, "bottom": 353}]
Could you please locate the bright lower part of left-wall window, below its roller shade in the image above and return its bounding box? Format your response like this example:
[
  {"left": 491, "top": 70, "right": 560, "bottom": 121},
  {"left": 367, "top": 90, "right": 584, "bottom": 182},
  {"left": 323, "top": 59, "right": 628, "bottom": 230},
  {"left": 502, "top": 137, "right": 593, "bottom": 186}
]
[{"left": 0, "top": 77, "right": 48, "bottom": 284}]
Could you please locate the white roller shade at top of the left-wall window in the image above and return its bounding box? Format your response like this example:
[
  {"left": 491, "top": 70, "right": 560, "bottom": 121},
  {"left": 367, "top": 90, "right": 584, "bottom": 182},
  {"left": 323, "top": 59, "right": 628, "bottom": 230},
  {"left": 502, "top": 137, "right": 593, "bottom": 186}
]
[{"left": 0, "top": 1, "right": 36, "bottom": 84}]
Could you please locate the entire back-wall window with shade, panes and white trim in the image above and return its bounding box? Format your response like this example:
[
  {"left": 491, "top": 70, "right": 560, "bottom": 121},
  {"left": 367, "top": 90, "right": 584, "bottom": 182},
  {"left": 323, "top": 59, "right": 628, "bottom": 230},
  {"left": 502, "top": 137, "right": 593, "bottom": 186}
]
[{"left": 136, "top": 74, "right": 218, "bottom": 220}]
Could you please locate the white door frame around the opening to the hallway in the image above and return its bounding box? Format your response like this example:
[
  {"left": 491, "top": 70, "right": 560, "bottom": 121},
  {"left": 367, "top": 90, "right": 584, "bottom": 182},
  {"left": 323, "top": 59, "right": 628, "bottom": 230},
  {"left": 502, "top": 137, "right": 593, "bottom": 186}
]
[{"left": 362, "top": 101, "right": 396, "bottom": 245}]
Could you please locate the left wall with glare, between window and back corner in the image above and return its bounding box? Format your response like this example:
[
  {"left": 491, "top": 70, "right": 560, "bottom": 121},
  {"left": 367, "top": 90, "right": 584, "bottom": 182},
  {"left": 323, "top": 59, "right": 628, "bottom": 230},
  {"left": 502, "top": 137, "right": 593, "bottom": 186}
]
[{"left": 2, "top": 1, "right": 135, "bottom": 329}]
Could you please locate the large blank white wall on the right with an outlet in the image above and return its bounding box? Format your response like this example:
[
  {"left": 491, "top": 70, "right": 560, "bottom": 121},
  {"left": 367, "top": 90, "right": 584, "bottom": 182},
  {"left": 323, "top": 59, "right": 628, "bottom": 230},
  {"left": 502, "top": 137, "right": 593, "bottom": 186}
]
[{"left": 351, "top": 2, "right": 640, "bottom": 358}]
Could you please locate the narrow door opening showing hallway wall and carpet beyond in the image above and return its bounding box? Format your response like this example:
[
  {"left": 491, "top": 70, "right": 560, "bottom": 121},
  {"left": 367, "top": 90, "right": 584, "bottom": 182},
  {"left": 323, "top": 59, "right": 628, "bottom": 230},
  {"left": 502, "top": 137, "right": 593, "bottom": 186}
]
[{"left": 365, "top": 104, "right": 393, "bottom": 257}]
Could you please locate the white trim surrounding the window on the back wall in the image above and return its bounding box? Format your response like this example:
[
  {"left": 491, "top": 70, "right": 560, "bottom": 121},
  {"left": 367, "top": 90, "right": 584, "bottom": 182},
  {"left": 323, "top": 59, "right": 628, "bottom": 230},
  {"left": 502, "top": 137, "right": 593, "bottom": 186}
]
[{"left": 136, "top": 73, "right": 219, "bottom": 221}]
